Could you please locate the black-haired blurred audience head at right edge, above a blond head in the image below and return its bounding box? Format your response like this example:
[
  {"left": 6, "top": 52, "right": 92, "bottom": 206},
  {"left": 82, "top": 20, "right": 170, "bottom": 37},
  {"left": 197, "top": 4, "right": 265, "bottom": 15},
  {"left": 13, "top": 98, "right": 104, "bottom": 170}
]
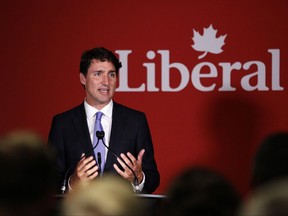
[{"left": 252, "top": 132, "right": 288, "bottom": 188}]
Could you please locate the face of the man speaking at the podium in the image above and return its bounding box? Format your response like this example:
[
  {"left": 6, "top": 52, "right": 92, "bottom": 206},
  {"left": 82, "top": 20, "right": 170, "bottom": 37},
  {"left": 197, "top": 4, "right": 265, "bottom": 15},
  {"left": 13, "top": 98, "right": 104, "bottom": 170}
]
[{"left": 80, "top": 59, "right": 117, "bottom": 109}]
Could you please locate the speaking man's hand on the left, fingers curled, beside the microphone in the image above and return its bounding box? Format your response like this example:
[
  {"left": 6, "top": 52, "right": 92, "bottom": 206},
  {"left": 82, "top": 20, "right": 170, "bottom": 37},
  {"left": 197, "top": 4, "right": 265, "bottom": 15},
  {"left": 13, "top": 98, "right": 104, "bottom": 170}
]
[{"left": 70, "top": 154, "right": 98, "bottom": 187}]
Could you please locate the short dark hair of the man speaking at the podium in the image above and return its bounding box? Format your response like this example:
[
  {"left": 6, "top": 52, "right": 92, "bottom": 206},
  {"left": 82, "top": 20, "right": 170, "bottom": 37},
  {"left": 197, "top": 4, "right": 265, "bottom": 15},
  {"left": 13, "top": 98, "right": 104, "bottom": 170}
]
[{"left": 80, "top": 47, "right": 122, "bottom": 76}]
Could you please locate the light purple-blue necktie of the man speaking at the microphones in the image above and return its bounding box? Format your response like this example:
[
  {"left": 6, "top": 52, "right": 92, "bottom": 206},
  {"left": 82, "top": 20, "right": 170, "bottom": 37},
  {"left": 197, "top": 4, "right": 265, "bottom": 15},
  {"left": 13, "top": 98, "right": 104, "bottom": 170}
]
[{"left": 93, "top": 112, "right": 105, "bottom": 175}]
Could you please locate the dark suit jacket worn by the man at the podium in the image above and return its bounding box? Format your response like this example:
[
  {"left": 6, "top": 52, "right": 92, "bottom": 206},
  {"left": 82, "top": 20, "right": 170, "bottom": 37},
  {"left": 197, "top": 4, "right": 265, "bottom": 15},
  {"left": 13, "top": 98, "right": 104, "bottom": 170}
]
[{"left": 49, "top": 102, "right": 160, "bottom": 193}]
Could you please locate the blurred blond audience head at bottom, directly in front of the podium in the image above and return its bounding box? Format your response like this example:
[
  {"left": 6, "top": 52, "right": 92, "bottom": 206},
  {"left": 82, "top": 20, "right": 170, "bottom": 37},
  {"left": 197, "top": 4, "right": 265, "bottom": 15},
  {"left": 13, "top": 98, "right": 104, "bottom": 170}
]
[{"left": 63, "top": 174, "right": 141, "bottom": 216}]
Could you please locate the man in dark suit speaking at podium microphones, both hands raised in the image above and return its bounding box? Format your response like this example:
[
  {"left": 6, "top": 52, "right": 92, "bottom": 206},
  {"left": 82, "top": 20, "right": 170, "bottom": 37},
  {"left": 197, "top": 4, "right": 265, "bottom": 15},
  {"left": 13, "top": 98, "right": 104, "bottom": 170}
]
[{"left": 49, "top": 47, "right": 160, "bottom": 193}]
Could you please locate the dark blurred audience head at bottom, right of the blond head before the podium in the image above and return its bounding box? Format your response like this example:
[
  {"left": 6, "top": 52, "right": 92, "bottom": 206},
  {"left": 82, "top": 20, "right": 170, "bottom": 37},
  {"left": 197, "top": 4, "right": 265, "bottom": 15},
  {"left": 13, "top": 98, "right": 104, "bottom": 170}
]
[{"left": 162, "top": 167, "right": 240, "bottom": 216}]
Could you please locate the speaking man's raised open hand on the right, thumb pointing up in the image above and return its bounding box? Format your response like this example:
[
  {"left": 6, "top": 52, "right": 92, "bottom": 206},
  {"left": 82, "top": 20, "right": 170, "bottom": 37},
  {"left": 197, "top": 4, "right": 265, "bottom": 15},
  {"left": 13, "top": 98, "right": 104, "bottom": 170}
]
[{"left": 113, "top": 149, "right": 145, "bottom": 183}]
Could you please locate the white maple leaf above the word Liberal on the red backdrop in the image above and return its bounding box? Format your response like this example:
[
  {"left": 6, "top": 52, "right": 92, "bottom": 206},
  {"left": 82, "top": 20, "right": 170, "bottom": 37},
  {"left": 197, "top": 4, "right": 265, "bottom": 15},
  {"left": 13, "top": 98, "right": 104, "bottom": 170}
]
[{"left": 192, "top": 24, "right": 227, "bottom": 59}]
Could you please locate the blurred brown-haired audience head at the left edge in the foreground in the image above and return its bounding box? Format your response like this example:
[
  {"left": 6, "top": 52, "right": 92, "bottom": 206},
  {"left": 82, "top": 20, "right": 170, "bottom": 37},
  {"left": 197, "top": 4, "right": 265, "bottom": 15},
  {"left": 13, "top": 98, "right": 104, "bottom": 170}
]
[{"left": 0, "top": 131, "right": 56, "bottom": 216}]
